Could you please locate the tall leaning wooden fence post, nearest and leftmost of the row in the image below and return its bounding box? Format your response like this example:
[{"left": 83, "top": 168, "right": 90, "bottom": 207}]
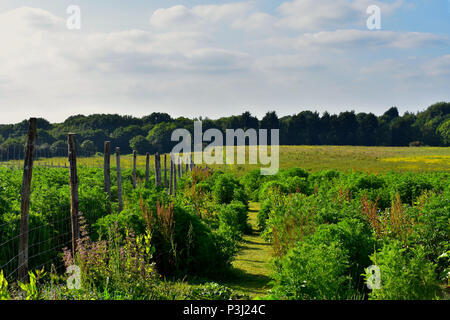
[{"left": 18, "top": 118, "right": 37, "bottom": 282}]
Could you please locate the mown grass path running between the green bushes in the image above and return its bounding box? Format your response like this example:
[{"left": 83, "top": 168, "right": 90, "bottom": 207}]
[{"left": 224, "top": 202, "right": 272, "bottom": 298}]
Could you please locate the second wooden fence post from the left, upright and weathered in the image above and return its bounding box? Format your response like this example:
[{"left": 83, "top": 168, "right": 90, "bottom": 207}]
[{"left": 67, "top": 133, "right": 80, "bottom": 257}]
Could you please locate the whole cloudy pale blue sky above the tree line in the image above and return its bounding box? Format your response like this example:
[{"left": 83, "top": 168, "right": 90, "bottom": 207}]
[{"left": 0, "top": 0, "right": 450, "bottom": 123}]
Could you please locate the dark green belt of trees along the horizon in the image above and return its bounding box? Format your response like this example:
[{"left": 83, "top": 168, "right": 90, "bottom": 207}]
[{"left": 0, "top": 102, "right": 450, "bottom": 159}]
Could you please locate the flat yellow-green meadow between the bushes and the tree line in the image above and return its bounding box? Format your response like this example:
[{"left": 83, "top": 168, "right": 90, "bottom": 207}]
[{"left": 1, "top": 146, "right": 450, "bottom": 175}]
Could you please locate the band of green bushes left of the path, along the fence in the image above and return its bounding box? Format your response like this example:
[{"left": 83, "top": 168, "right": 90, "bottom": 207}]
[{"left": 0, "top": 164, "right": 249, "bottom": 286}]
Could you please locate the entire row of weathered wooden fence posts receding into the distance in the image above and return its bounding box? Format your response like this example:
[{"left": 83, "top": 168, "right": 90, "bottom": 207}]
[{"left": 18, "top": 118, "right": 195, "bottom": 282}]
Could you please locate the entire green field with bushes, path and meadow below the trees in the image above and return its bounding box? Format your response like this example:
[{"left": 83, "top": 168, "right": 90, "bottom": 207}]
[{"left": 0, "top": 146, "right": 450, "bottom": 300}]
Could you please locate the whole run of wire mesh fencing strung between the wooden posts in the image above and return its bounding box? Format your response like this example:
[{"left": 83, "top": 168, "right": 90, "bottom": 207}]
[{"left": 0, "top": 122, "right": 194, "bottom": 281}]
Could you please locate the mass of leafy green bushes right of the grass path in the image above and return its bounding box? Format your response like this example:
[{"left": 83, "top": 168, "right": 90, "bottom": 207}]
[{"left": 241, "top": 169, "right": 450, "bottom": 299}]
